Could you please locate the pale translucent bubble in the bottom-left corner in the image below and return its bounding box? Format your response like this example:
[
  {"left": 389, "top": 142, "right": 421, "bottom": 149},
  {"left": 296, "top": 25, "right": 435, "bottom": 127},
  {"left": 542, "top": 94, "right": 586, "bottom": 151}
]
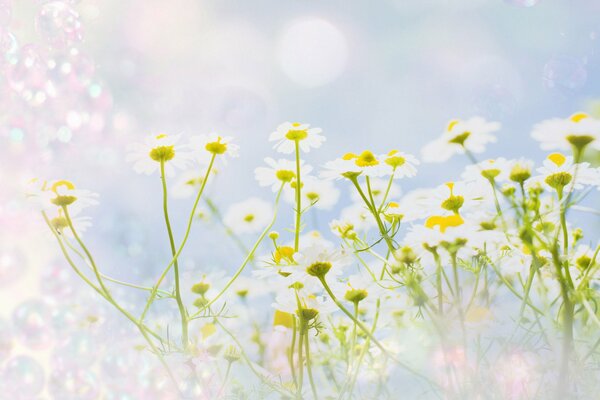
[{"left": 0, "top": 356, "right": 44, "bottom": 400}]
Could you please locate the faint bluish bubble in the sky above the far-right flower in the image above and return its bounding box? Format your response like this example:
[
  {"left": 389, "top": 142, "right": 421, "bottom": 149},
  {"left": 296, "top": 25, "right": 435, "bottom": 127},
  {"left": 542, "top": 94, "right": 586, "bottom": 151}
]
[{"left": 542, "top": 56, "right": 587, "bottom": 90}]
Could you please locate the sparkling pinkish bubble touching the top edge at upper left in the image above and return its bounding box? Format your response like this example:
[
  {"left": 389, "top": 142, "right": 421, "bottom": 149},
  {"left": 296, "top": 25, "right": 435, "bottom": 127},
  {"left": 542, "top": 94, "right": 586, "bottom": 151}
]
[{"left": 35, "top": 1, "right": 82, "bottom": 48}]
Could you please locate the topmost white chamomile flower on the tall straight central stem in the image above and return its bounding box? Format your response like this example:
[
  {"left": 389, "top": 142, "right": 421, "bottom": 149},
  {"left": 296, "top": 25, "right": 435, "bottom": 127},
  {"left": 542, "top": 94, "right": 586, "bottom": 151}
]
[{"left": 269, "top": 122, "right": 326, "bottom": 154}]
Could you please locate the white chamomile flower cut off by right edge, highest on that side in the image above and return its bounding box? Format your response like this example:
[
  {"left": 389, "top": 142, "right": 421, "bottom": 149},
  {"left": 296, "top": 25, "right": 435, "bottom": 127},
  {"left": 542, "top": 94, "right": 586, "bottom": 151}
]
[{"left": 531, "top": 112, "right": 600, "bottom": 155}]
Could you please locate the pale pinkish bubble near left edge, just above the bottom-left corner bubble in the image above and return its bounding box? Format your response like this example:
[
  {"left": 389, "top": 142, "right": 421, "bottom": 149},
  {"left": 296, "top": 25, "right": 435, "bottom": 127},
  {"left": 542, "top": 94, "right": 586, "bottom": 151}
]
[{"left": 12, "top": 299, "right": 51, "bottom": 349}]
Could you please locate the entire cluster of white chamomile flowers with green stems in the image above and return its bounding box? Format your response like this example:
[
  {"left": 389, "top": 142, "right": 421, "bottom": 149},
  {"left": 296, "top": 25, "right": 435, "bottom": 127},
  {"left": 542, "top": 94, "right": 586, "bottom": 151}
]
[{"left": 36, "top": 113, "right": 600, "bottom": 399}]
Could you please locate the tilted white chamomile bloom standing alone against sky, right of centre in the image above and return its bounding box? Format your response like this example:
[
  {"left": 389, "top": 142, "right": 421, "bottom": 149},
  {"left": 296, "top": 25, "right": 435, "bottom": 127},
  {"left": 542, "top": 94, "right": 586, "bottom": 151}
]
[{"left": 421, "top": 117, "right": 500, "bottom": 162}]
